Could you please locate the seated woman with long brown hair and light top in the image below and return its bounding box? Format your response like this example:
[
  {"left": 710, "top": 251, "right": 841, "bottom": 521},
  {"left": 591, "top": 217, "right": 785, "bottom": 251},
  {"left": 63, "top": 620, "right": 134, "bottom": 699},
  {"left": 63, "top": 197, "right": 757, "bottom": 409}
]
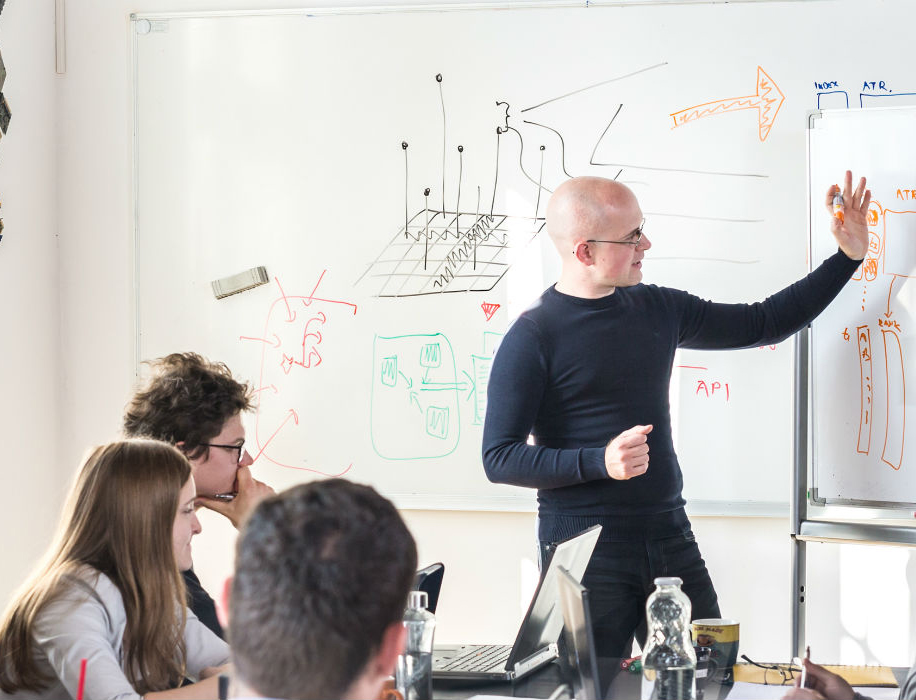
[{"left": 0, "top": 440, "right": 229, "bottom": 700}]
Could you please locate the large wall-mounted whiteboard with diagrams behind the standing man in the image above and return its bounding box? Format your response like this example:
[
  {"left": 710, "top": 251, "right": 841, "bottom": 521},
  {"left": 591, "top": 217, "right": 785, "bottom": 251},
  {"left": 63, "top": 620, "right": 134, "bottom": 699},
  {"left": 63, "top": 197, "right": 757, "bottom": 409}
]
[{"left": 131, "top": 0, "right": 916, "bottom": 512}]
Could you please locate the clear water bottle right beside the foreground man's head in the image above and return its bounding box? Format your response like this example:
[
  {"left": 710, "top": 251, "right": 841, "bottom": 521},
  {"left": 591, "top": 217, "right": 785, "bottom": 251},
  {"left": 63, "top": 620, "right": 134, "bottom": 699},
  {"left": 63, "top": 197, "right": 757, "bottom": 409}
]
[{"left": 395, "top": 591, "right": 436, "bottom": 700}]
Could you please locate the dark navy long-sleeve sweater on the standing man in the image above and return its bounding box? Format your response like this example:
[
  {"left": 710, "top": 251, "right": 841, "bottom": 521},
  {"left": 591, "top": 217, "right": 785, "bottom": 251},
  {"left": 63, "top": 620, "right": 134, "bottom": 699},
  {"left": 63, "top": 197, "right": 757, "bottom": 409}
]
[{"left": 483, "top": 252, "right": 859, "bottom": 541}]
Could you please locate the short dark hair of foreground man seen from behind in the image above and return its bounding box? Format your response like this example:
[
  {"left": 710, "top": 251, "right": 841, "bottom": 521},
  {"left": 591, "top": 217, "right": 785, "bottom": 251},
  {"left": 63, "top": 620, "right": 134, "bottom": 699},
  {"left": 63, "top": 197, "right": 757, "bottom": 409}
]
[{"left": 229, "top": 479, "right": 417, "bottom": 700}]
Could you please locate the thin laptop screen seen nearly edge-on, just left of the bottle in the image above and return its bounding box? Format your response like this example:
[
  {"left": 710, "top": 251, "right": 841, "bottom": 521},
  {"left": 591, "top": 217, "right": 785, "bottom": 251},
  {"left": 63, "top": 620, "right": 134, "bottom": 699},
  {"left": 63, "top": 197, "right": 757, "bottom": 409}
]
[{"left": 558, "top": 567, "right": 602, "bottom": 700}]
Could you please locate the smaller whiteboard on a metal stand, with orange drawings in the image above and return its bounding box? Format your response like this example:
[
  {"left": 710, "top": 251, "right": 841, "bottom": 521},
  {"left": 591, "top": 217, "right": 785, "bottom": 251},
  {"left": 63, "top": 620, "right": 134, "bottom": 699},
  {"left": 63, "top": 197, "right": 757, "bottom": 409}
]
[{"left": 809, "top": 107, "right": 916, "bottom": 508}]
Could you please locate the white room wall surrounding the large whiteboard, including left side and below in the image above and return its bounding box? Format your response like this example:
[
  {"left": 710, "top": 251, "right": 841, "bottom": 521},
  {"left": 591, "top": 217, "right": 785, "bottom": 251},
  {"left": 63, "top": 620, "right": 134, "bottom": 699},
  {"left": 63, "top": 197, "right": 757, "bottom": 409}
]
[{"left": 0, "top": 0, "right": 914, "bottom": 665}]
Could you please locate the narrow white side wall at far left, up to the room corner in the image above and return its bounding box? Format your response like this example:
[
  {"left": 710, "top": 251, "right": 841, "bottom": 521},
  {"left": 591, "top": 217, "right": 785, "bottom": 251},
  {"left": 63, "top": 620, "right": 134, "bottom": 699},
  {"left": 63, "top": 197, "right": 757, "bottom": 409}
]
[{"left": 0, "top": 0, "right": 66, "bottom": 602}]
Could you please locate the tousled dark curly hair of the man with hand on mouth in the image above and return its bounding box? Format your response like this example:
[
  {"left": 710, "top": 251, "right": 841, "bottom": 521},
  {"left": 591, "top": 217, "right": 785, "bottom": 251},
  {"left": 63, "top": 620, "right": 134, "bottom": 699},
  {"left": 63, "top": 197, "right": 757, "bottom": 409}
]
[{"left": 124, "top": 352, "right": 251, "bottom": 459}]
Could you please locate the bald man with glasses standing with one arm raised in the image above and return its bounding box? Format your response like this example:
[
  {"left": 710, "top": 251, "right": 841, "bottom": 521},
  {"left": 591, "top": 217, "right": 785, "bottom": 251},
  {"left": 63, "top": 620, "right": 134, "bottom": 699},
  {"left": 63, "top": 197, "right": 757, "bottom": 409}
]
[{"left": 483, "top": 172, "right": 871, "bottom": 657}]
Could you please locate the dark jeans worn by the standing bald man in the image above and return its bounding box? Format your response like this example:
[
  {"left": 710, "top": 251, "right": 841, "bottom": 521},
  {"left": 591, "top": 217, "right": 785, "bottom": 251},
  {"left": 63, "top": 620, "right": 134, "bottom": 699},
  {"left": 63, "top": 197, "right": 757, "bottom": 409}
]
[{"left": 539, "top": 530, "right": 720, "bottom": 658}]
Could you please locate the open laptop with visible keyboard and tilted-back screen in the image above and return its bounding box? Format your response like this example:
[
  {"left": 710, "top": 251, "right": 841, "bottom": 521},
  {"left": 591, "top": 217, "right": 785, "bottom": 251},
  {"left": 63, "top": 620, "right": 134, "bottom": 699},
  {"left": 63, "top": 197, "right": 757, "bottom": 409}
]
[{"left": 433, "top": 525, "right": 601, "bottom": 681}]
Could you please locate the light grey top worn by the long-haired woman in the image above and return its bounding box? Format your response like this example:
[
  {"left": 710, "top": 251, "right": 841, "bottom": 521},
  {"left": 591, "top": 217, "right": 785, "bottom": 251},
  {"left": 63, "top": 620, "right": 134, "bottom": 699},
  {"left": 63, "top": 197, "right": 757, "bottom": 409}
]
[{"left": 0, "top": 568, "right": 229, "bottom": 700}]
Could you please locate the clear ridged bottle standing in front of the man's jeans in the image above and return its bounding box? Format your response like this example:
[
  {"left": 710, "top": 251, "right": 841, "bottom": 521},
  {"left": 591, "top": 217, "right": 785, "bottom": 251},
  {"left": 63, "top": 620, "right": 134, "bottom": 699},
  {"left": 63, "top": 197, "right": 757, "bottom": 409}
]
[{"left": 642, "top": 577, "right": 697, "bottom": 700}]
